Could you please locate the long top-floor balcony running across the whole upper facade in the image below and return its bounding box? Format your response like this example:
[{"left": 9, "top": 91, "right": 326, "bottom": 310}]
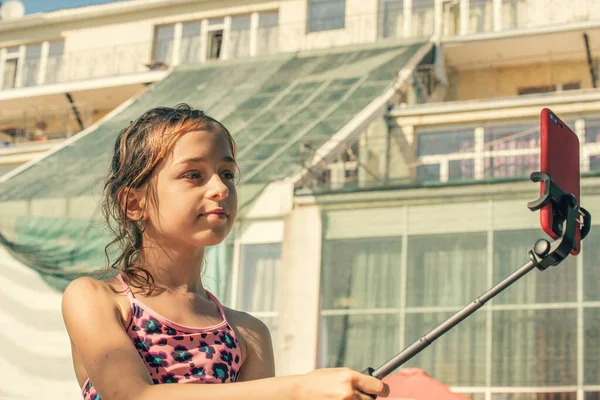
[{"left": 0, "top": 0, "right": 600, "bottom": 94}]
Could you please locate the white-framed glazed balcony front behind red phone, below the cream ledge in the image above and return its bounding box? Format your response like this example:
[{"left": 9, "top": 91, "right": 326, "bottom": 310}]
[{"left": 297, "top": 109, "right": 600, "bottom": 191}]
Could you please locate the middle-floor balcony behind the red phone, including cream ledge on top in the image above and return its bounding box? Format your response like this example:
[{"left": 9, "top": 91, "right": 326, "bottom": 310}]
[{"left": 296, "top": 90, "right": 600, "bottom": 193}]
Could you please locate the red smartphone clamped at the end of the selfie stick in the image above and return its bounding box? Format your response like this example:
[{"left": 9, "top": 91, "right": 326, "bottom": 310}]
[{"left": 540, "top": 108, "right": 581, "bottom": 255}]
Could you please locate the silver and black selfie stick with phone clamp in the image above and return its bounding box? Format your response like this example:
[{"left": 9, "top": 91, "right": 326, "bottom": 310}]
[{"left": 363, "top": 172, "right": 592, "bottom": 390}]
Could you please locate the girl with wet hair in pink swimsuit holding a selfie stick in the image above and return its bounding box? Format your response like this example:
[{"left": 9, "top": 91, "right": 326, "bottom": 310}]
[{"left": 62, "top": 105, "right": 389, "bottom": 400}]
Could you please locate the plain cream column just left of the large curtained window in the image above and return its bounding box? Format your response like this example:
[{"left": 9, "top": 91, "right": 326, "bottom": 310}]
[{"left": 277, "top": 206, "right": 322, "bottom": 376}]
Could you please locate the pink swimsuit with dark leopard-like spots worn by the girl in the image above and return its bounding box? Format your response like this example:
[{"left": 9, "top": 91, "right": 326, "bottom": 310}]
[{"left": 82, "top": 275, "right": 242, "bottom": 400}]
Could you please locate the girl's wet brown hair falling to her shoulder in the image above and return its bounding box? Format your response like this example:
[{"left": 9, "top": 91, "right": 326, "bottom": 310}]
[{"left": 102, "top": 104, "right": 235, "bottom": 294}]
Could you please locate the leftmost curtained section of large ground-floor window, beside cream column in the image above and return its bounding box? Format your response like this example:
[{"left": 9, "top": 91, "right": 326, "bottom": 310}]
[{"left": 319, "top": 237, "right": 402, "bottom": 370}]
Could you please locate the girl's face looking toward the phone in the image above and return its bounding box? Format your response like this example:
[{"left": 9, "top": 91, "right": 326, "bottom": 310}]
[{"left": 146, "top": 131, "right": 237, "bottom": 248}]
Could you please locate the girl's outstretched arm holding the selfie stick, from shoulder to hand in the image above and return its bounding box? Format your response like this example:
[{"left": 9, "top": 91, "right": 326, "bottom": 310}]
[{"left": 62, "top": 278, "right": 389, "bottom": 400}]
